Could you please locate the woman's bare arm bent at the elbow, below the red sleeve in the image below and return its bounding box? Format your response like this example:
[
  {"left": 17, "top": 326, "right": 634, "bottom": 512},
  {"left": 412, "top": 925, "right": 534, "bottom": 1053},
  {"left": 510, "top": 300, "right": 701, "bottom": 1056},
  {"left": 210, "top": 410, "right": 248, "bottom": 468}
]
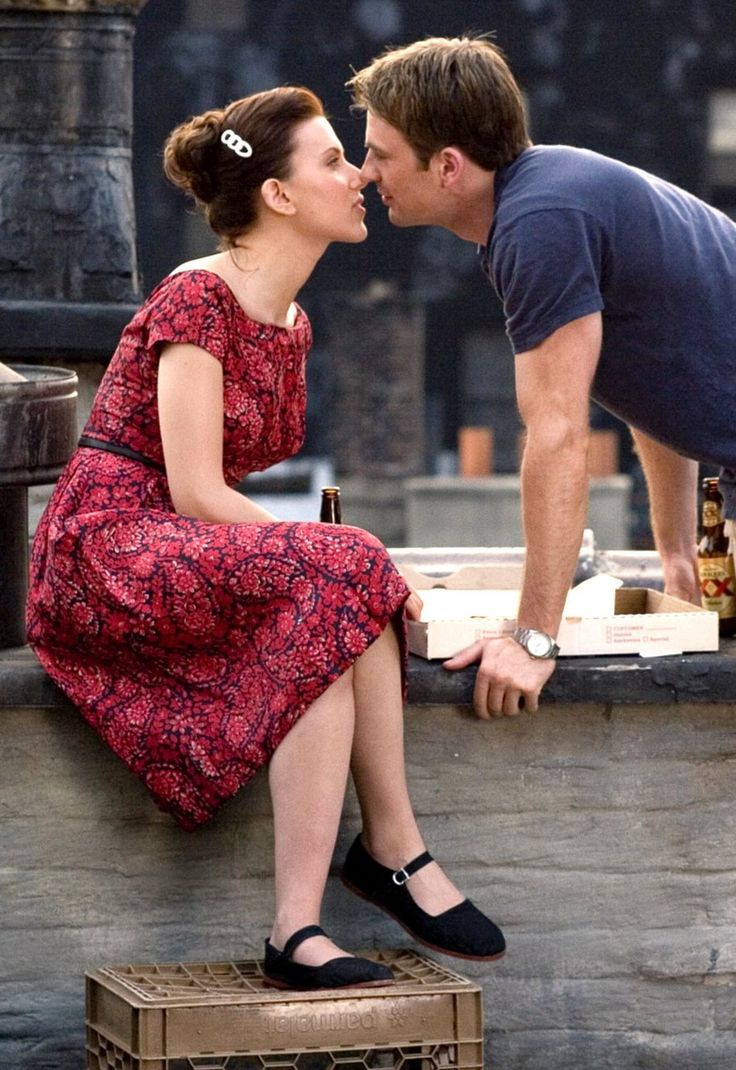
[{"left": 158, "top": 342, "right": 276, "bottom": 523}]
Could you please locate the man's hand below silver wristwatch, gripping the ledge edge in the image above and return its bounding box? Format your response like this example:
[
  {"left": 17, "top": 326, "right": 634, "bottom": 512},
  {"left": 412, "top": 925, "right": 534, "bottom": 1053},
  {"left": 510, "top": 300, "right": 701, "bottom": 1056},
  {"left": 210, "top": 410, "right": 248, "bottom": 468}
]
[{"left": 444, "top": 637, "right": 555, "bottom": 720}]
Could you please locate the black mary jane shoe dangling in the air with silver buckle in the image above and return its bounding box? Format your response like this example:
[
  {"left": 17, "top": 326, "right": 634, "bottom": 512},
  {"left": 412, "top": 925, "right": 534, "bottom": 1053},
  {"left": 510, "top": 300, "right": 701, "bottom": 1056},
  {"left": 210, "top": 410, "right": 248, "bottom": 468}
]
[{"left": 341, "top": 836, "right": 506, "bottom": 960}]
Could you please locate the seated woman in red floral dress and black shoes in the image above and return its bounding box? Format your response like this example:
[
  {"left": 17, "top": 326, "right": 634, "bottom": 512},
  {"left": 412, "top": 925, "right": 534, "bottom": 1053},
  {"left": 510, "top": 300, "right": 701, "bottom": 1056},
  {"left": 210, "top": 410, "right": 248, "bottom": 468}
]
[{"left": 28, "top": 88, "right": 504, "bottom": 989}]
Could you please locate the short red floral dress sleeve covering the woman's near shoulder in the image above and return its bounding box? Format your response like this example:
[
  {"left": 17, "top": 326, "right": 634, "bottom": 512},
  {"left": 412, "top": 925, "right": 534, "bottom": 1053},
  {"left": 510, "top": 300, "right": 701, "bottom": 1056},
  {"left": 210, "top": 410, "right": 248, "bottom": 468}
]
[{"left": 145, "top": 271, "right": 228, "bottom": 364}]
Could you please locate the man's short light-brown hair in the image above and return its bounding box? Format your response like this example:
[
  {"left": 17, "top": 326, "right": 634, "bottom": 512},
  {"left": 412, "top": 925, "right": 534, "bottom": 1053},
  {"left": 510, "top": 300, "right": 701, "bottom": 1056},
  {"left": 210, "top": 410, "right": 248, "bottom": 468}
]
[{"left": 347, "top": 36, "right": 531, "bottom": 171}]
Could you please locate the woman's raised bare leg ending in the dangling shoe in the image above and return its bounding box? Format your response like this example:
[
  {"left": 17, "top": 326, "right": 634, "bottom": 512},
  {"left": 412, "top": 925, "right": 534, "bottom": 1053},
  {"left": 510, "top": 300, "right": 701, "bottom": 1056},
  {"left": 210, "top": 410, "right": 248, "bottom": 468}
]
[{"left": 351, "top": 624, "right": 464, "bottom": 914}]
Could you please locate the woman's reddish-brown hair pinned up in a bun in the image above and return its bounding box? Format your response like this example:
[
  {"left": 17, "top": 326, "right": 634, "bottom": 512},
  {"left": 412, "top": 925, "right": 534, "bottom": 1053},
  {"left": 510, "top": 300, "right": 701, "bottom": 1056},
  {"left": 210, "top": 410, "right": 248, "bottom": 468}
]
[{"left": 164, "top": 86, "right": 324, "bottom": 247}]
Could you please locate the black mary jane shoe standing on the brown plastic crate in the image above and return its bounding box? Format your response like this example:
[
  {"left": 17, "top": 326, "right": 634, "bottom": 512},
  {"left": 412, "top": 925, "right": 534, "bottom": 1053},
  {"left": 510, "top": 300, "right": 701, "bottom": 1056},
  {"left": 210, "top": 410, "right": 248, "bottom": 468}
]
[{"left": 263, "top": 926, "right": 394, "bottom": 992}]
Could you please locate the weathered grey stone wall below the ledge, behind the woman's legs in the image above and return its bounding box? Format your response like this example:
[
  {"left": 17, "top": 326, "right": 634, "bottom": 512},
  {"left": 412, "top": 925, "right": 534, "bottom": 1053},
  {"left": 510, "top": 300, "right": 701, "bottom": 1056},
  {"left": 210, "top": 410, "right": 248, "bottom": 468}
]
[{"left": 0, "top": 703, "right": 736, "bottom": 1070}]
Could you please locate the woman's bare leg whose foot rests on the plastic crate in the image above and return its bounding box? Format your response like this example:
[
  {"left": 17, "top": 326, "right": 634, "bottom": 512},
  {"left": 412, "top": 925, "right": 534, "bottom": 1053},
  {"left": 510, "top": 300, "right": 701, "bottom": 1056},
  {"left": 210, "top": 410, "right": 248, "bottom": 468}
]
[{"left": 269, "top": 669, "right": 355, "bottom": 966}]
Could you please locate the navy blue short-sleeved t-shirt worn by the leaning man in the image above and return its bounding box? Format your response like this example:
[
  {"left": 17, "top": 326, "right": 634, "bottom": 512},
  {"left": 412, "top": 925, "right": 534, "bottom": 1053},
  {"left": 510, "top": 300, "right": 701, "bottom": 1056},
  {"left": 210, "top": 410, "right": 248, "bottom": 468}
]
[{"left": 482, "top": 146, "right": 736, "bottom": 498}]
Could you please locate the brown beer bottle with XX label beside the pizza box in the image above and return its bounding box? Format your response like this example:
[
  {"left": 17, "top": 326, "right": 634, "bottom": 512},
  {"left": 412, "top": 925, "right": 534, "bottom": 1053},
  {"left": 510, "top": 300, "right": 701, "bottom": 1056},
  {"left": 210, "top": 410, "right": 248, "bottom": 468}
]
[{"left": 697, "top": 478, "right": 736, "bottom": 636}]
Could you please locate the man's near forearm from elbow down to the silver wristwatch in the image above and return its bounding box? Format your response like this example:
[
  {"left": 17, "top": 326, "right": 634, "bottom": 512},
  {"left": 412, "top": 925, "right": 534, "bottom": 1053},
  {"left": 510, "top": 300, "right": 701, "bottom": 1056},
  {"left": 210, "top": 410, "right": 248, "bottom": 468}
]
[{"left": 519, "top": 438, "right": 587, "bottom": 636}]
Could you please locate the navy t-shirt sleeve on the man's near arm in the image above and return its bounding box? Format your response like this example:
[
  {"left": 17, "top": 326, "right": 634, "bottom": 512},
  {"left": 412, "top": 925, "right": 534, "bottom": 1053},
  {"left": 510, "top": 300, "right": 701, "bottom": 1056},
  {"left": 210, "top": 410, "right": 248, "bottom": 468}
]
[{"left": 490, "top": 209, "right": 604, "bottom": 353}]
